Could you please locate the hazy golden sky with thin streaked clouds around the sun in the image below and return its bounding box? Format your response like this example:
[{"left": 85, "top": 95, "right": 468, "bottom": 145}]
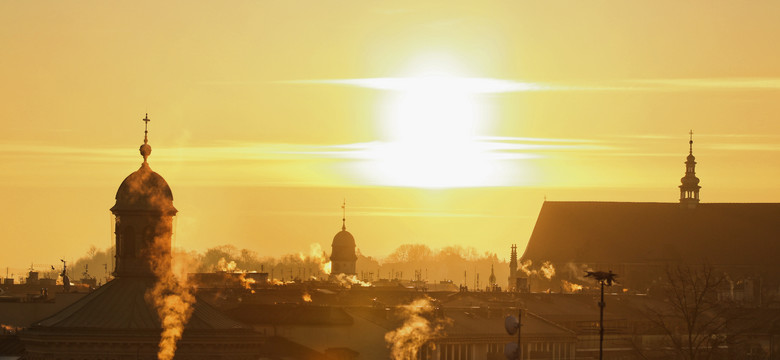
[{"left": 0, "top": 0, "right": 780, "bottom": 276}]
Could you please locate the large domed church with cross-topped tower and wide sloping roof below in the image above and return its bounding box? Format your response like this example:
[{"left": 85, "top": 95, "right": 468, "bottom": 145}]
[{"left": 20, "top": 117, "right": 265, "bottom": 360}]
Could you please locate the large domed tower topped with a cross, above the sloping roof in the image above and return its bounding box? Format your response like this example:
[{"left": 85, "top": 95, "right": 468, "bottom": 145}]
[{"left": 111, "top": 115, "right": 177, "bottom": 277}]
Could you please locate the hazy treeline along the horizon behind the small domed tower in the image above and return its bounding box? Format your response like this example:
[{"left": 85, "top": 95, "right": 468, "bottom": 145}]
[{"left": 68, "top": 244, "right": 509, "bottom": 288}]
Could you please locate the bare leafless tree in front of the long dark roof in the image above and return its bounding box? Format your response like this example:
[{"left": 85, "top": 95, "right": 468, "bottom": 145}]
[{"left": 647, "top": 264, "right": 733, "bottom": 360}]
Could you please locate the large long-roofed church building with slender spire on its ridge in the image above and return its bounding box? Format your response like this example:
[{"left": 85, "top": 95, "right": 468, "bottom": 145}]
[{"left": 521, "top": 134, "right": 780, "bottom": 292}]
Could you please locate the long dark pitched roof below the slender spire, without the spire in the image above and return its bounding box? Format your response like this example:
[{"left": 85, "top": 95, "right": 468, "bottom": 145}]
[{"left": 522, "top": 201, "right": 780, "bottom": 267}]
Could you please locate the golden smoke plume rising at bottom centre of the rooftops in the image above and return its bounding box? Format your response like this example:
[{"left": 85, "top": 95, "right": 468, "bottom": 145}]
[{"left": 385, "top": 296, "right": 447, "bottom": 360}]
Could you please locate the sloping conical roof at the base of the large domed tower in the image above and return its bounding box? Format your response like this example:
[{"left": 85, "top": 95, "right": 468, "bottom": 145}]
[{"left": 33, "top": 277, "right": 250, "bottom": 332}]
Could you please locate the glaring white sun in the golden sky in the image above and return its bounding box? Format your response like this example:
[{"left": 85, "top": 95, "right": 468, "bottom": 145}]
[{"left": 358, "top": 75, "right": 496, "bottom": 188}]
